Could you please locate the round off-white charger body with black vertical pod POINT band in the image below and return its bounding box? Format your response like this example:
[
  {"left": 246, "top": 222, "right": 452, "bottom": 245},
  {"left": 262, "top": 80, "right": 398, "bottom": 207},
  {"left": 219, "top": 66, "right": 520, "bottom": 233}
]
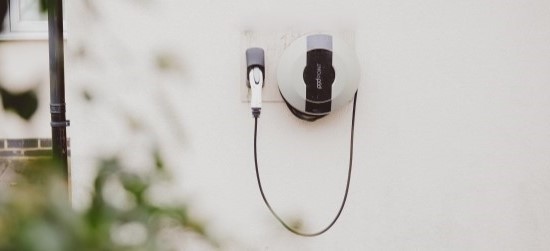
[{"left": 277, "top": 34, "right": 359, "bottom": 120}]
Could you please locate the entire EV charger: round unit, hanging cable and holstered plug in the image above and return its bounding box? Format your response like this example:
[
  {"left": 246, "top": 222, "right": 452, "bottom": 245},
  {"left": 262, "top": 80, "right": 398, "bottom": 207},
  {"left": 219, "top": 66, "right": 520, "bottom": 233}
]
[{"left": 246, "top": 34, "right": 360, "bottom": 237}]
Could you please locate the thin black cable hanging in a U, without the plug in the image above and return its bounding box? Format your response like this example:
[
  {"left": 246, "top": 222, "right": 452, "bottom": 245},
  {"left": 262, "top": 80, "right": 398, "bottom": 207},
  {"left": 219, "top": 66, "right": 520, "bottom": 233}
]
[{"left": 254, "top": 92, "right": 357, "bottom": 237}]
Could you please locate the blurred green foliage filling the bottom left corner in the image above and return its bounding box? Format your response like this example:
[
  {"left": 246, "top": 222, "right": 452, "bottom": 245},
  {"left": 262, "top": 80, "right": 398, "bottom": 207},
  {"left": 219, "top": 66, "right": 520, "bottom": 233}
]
[{"left": 0, "top": 156, "right": 216, "bottom": 251}]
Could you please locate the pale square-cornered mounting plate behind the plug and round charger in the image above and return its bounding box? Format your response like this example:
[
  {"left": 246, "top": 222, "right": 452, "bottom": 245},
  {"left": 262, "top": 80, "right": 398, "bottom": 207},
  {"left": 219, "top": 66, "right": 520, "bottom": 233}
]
[{"left": 243, "top": 31, "right": 355, "bottom": 102}]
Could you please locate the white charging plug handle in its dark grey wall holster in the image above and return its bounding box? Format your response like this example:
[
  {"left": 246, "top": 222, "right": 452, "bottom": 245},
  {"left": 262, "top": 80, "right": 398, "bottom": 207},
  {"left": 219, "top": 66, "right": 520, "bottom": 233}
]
[{"left": 246, "top": 48, "right": 265, "bottom": 118}]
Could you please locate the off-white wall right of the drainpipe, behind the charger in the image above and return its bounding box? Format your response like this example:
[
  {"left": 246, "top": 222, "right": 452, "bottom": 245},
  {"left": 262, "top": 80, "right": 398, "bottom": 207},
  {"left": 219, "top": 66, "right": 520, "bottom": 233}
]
[{"left": 67, "top": 0, "right": 550, "bottom": 250}]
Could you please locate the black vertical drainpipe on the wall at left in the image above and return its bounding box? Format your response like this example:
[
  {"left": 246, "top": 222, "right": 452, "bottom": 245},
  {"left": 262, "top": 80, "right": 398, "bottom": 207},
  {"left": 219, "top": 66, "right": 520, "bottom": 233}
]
[{"left": 47, "top": 0, "right": 69, "bottom": 179}]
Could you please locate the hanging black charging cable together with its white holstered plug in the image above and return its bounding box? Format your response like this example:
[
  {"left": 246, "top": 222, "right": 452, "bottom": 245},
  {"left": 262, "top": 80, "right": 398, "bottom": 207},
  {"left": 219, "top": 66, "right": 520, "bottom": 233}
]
[{"left": 246, "top": 48, "right": 357, "bottom": 237}]
